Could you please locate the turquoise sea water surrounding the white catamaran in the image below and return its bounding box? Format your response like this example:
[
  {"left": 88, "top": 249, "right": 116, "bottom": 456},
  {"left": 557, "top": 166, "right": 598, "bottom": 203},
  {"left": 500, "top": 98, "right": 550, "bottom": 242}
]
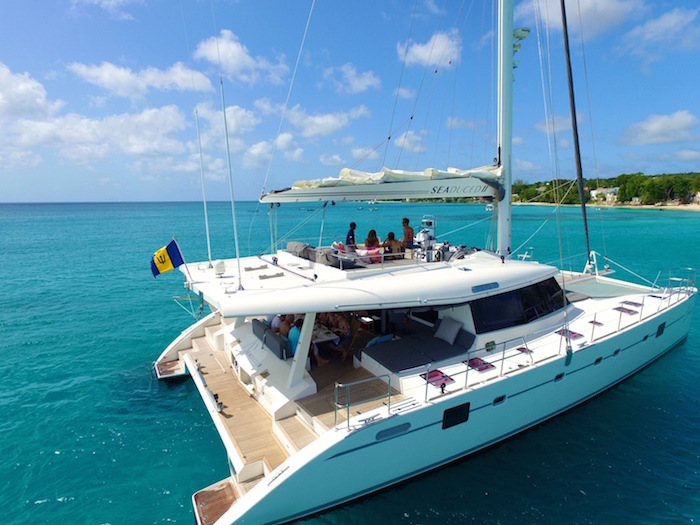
[{"left": 0, "top": 199, "right": 700, "bottom": 525}]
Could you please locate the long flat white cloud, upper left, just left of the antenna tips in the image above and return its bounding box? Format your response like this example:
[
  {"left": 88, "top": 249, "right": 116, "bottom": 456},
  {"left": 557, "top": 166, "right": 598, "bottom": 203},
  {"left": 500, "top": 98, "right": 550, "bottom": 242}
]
[{"left": 68, "top": 62, "right": 213, "bottom": 98}]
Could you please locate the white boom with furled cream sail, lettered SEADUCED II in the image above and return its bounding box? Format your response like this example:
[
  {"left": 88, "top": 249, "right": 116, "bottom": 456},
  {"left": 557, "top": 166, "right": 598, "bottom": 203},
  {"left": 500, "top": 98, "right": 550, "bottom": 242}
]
[{"left": 260, "top": 165, "right": 504, "bottom": 203}]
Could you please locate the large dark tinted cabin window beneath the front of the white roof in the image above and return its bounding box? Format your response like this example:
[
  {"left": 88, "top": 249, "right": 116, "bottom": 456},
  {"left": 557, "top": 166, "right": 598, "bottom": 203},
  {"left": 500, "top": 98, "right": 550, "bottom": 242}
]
[{"left": 470, "top": 277, "right": 564, "bottom": 334}]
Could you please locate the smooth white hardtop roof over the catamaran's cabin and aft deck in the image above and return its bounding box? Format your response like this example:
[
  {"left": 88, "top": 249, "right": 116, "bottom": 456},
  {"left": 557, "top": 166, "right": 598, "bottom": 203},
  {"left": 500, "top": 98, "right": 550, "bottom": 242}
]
[{"left": 180, "top": 250, "right": 558, "bottom": 317}]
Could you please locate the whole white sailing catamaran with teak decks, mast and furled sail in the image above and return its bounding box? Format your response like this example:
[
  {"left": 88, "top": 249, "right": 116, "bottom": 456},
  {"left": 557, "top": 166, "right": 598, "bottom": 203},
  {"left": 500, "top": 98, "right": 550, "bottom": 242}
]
[{"left": 155, "top": 0, "right": 697, "bottom": 525}]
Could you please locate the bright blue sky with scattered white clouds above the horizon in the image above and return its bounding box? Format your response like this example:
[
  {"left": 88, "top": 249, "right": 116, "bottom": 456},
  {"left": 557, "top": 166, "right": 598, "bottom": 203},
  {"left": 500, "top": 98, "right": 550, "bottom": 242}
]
[{"left": 0, "top": 0, "right": 700, "bottom": 202}]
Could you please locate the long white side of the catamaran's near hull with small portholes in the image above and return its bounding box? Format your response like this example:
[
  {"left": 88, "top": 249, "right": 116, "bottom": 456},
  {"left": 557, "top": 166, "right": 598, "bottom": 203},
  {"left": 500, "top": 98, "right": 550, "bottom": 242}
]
[{"left": 217, "top": 294, "right": 695, "bottom": 525}]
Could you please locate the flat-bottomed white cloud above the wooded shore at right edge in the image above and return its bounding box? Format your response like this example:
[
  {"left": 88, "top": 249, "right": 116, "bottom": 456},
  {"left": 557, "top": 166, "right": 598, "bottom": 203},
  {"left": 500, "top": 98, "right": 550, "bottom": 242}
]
[{"left": 621, "top": 110, "right": 700, "bottom": 146}]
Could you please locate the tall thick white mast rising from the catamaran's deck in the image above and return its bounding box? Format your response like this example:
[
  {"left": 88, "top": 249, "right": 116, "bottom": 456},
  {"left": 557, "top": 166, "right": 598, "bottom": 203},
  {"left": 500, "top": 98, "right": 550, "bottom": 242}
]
[{"left": 497, "top": 0, "right": 513, "bottom": 256}]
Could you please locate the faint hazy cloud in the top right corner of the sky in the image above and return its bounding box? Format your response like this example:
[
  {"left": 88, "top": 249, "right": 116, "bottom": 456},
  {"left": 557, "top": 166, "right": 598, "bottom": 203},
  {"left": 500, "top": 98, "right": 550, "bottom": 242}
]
[{"left": 622, "top": 8, "right": 700, "bottom": 63}]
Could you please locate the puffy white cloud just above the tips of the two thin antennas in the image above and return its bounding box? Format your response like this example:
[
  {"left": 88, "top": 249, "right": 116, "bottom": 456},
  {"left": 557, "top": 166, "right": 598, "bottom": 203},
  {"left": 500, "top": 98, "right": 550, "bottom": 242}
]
[{"left": 194, "top": 29, "right": 289, "bottom": 85}]
